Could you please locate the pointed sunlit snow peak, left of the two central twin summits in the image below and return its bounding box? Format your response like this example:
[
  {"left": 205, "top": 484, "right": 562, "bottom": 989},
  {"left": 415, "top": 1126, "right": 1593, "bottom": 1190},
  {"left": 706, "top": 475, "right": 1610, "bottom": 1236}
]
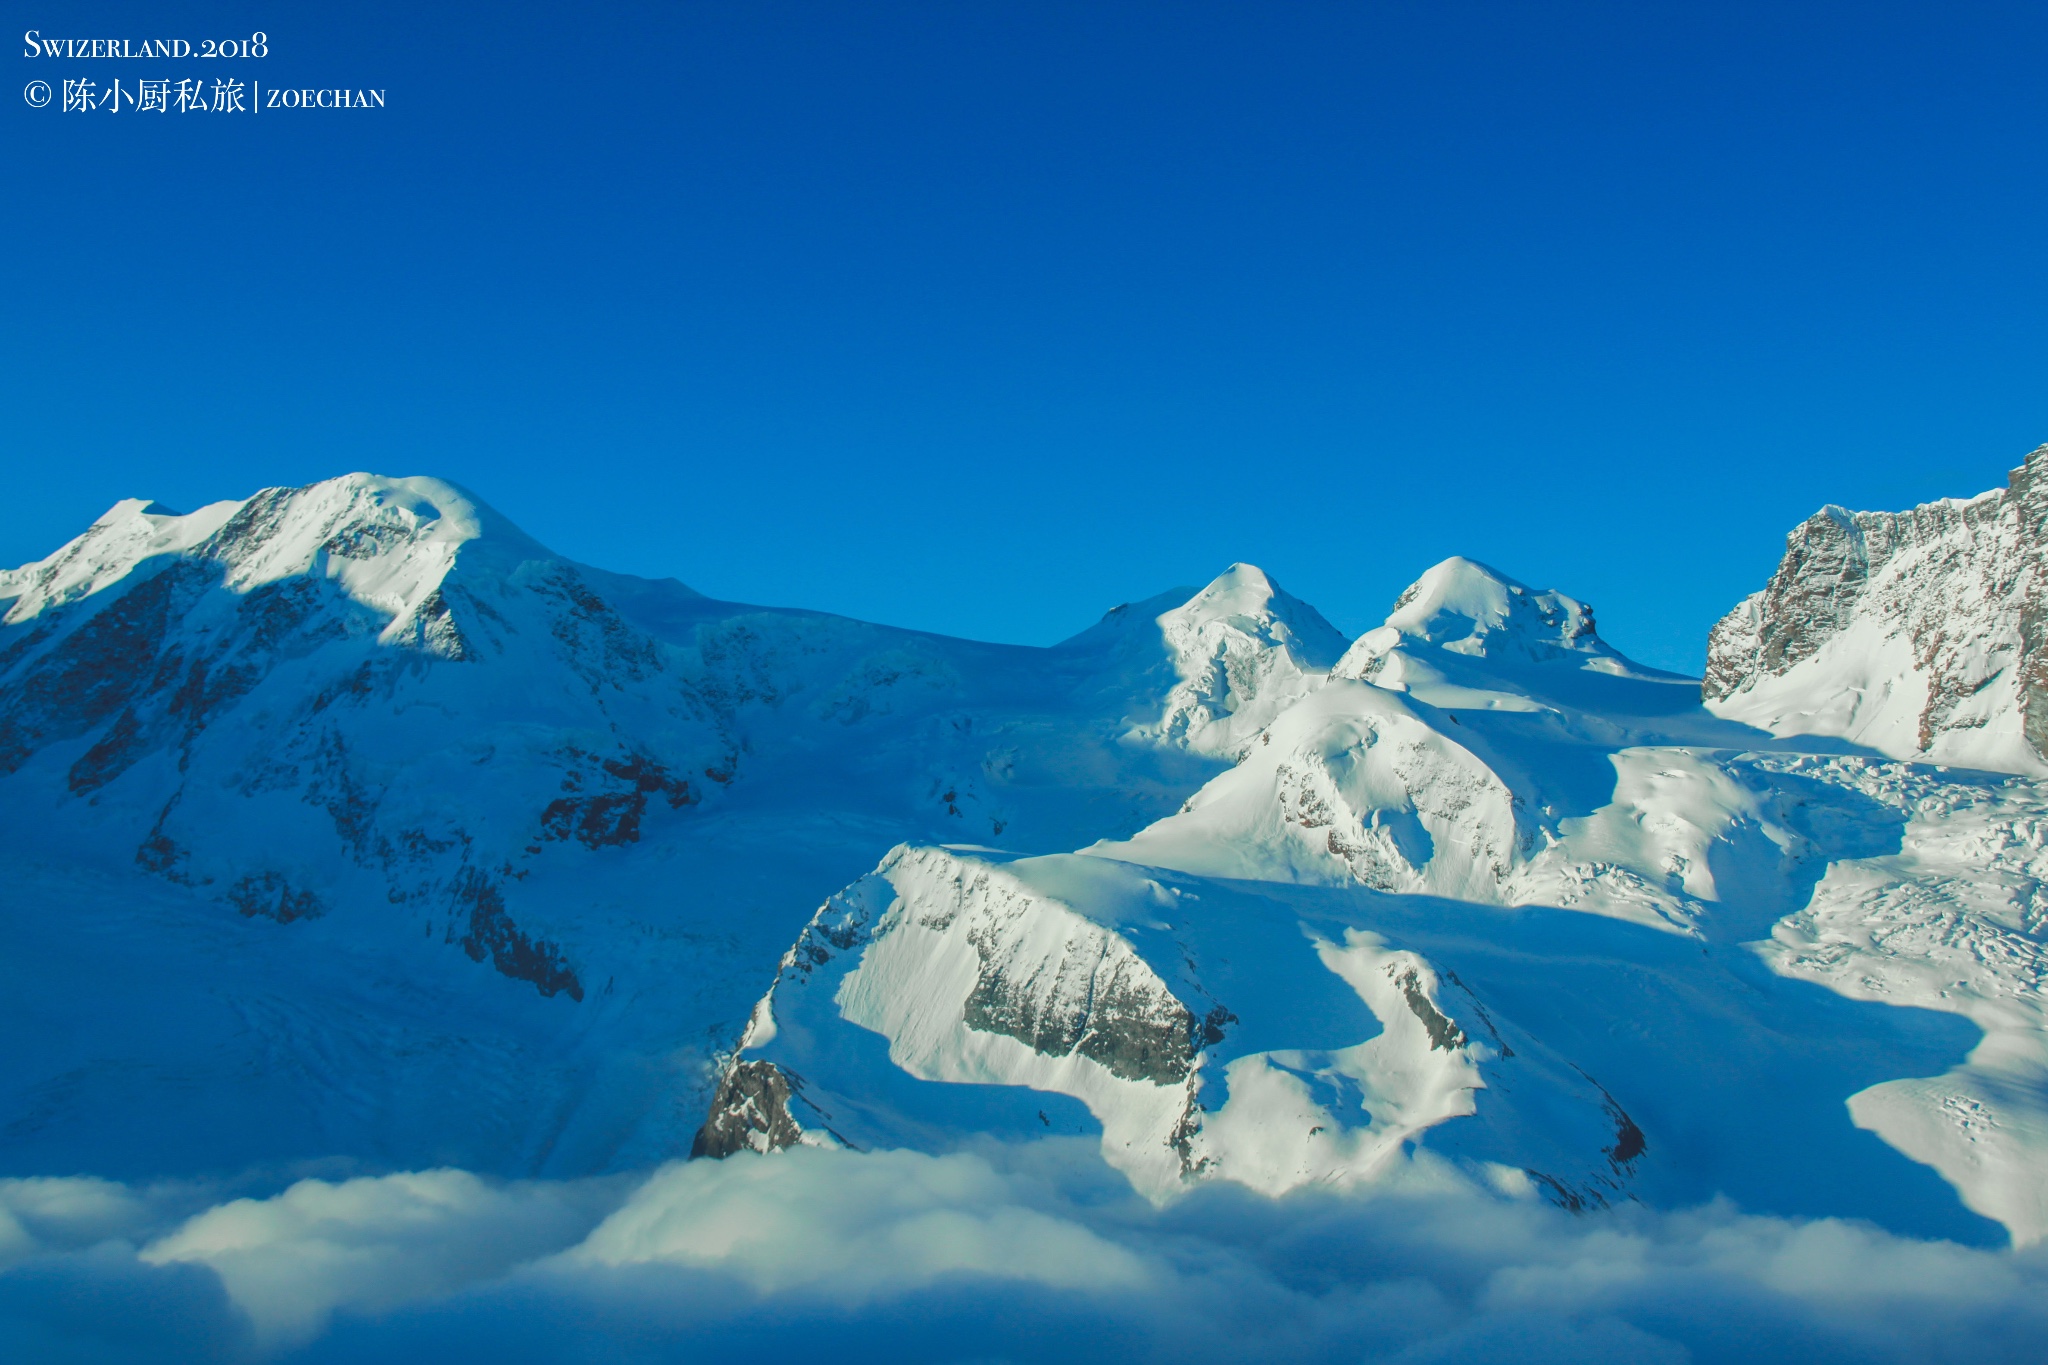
[{"left": 1143, "top": 565, "right": 1346, "bottom": 757}]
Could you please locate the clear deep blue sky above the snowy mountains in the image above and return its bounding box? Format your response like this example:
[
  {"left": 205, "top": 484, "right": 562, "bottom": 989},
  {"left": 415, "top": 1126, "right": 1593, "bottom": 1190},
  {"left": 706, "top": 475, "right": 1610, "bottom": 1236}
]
[{"left": 0, "top": 0, "right": 2048, "bottom": 671}]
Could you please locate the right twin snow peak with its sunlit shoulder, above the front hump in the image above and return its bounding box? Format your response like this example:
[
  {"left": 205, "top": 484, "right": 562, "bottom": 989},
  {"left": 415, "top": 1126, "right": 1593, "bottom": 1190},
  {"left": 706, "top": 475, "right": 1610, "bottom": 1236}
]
[{"left": 1087, "top": 559, "right": 1796, "bottom": 929}]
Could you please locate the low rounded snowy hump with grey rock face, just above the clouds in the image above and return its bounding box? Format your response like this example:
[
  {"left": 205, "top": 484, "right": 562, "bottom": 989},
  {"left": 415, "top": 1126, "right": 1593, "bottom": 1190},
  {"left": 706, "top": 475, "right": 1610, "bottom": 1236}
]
[{"left": 696, "top": 847, "right": 1647, "bottom": 1207}]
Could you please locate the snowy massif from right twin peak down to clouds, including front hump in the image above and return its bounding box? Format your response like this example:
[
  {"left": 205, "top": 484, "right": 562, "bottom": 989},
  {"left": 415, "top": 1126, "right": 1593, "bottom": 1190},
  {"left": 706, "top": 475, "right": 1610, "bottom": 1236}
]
[{"left": 698, "top": 561, "right": 2048, "bottom": 1242}]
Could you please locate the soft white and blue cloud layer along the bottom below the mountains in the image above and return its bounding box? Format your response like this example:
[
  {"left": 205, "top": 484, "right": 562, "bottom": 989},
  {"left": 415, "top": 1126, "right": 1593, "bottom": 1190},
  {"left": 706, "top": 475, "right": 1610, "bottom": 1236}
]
[{"left": 0, "top": 1140, "right": 2048, "bottom": 1365}]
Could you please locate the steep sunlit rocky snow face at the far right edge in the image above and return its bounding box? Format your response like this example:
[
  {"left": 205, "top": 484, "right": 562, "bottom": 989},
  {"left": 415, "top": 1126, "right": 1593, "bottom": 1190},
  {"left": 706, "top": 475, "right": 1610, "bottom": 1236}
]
[{"left": 1706, "top": 446, "right": 2048, "bottom": 774}]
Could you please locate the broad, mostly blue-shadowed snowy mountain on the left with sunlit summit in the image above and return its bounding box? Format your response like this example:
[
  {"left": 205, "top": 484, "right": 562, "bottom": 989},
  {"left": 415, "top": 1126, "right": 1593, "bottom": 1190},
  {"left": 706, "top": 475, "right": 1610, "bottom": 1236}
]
[{"left": 0, "top": 475, "right": 1284, "bottom": 1173}]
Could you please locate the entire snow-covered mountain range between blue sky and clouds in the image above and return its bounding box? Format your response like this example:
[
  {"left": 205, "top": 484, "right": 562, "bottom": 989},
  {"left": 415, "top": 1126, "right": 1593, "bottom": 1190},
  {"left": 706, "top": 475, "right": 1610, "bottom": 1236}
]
[{"left": 0, "top": 472, "right": 2048, "bottom": 1242}]
